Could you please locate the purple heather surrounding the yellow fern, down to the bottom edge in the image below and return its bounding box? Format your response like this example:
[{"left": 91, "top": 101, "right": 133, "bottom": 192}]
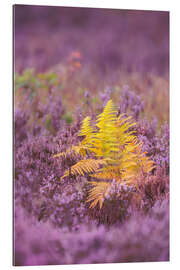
[{"left": 14, "top": 76, "right": 169, "bottom": 265}]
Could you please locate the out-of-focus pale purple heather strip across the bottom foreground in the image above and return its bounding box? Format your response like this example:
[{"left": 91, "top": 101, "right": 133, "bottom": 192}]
[{"left": 14, "top": 199, "right": 169, "bottom": 266}]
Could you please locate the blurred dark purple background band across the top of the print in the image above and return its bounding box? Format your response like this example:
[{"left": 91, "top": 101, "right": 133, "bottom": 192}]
[{"left": 14, "top": 5, "right": 169, "bottom": 76}]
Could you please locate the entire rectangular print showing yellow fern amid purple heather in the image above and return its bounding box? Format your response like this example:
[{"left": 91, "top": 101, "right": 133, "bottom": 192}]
[{"left": 14, "top": 5, "right": 169, "bottom": 266}]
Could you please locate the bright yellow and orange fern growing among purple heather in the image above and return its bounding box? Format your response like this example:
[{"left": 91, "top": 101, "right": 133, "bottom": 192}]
[{"left": 54, "top": 100, "right": 154, "bottom": 208}]
